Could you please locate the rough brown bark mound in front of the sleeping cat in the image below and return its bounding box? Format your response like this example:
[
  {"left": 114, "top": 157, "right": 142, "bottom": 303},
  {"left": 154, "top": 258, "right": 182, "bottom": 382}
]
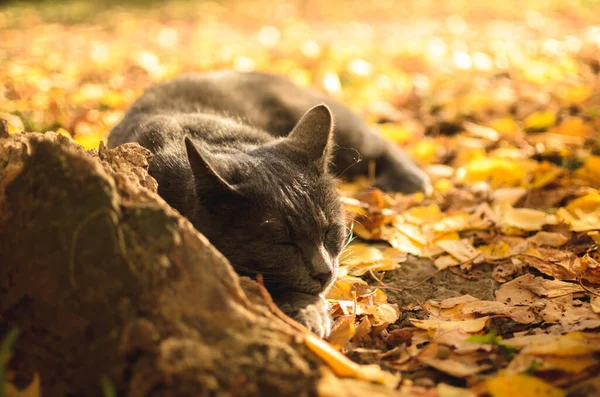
[{"left": 0, "top": 133, "right": 318, "bottom": 396}]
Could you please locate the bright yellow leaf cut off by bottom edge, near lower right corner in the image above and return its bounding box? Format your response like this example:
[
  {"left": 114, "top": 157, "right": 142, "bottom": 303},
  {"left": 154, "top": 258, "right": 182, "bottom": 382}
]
[{"left": 485, "top": 375, "right": 565, "bottom": 397}]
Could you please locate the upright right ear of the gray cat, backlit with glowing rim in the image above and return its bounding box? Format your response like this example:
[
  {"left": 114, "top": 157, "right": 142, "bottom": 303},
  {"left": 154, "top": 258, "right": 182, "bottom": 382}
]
[{"left": 287, "top": 104, "right": 333, "bottom": 169}]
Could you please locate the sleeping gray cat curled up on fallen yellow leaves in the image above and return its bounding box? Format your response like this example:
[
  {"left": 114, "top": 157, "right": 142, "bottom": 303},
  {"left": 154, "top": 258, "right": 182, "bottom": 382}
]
[{"left": 108, "top": 71, "right": 430, "bottom": 336}]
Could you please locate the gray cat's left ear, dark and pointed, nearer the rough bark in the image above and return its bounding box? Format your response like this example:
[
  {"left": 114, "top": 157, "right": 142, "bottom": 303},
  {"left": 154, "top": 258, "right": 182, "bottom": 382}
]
[{"left": 185, "top": 137, "right": 235, "bottom": 192}]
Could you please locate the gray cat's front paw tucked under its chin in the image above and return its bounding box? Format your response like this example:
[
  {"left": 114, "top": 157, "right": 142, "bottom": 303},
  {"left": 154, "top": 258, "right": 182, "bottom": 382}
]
[{"left": 273, "top": 292, "right": 332, "bottom": 338}]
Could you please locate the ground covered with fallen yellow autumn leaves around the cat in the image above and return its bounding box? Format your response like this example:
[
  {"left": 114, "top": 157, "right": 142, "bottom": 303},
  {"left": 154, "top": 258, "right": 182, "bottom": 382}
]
[{"left": 0, "top": 0, "right": 600, "bottom": 397}]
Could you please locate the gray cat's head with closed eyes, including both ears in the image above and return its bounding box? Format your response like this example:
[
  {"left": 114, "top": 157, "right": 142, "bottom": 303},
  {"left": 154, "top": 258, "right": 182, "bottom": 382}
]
[{"left": 186, "top": 105, "right": 347, "bottom": 294}]
